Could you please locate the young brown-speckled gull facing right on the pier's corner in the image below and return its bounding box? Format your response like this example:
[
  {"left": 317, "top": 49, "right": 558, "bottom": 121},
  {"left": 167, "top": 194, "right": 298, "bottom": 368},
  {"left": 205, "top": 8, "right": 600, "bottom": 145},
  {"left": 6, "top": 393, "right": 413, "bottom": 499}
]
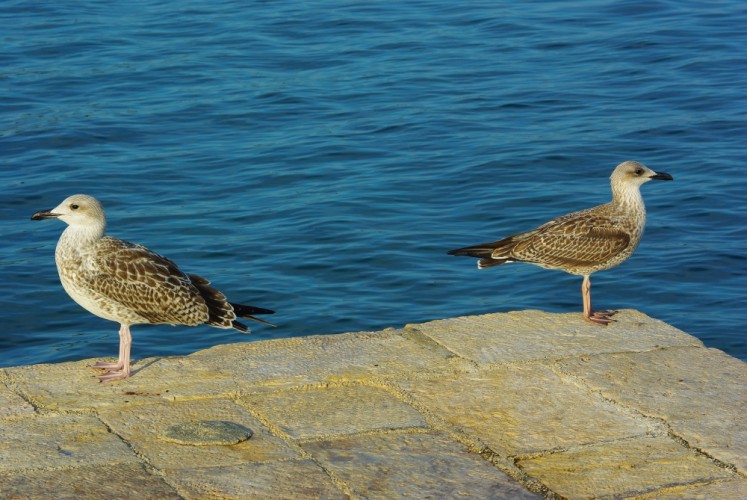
[{"left": 449, "top": 161, "right": 672, "bottom": 326}]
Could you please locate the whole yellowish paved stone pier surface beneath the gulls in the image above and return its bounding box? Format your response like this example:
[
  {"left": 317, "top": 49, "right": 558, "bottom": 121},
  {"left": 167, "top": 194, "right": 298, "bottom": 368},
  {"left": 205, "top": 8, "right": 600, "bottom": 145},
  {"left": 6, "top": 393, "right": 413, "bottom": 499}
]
[{"left": 0, "top": 311, "right": 747, "bottom": 499}]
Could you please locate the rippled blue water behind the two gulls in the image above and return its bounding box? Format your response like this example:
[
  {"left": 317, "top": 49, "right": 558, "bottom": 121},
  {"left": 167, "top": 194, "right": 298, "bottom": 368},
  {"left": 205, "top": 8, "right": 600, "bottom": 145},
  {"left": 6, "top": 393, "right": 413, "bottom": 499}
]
[{"left": 0, "top": 0, "right": 747, "bottom": 366}]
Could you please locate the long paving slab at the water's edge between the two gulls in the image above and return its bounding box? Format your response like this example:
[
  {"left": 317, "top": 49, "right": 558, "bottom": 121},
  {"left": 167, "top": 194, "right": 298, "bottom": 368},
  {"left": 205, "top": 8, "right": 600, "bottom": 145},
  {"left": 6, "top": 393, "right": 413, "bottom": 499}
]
[{"left": 190, "top": 330, "right": 453, "bottom": 388}]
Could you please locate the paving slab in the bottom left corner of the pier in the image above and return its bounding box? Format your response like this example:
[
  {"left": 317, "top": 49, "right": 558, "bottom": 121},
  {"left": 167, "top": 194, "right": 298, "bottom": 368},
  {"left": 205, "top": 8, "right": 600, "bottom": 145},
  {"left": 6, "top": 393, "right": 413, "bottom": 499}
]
[{"left": 0, "top": 463, "right": 181, "bottom": 500}]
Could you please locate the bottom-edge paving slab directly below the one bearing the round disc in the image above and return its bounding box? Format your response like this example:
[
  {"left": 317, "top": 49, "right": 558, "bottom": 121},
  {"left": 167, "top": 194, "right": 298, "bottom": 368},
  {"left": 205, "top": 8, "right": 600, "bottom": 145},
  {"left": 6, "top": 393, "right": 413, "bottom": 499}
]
[{"left": 166, "top": 460, "right": 348, "bottom": 500}]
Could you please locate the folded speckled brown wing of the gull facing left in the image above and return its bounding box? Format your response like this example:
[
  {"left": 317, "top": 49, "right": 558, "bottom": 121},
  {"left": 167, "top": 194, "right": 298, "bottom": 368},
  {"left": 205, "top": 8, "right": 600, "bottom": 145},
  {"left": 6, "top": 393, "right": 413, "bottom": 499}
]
[{"left": 86, "top": 237, "right": 208, "bottom": 325}]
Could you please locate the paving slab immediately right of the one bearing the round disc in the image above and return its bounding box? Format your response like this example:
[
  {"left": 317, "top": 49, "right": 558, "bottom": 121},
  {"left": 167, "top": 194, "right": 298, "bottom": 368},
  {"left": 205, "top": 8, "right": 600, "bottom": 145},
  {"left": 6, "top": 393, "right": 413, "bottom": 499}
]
[{"left": 244, "top": 385, "right": 425, "bottom": 439}]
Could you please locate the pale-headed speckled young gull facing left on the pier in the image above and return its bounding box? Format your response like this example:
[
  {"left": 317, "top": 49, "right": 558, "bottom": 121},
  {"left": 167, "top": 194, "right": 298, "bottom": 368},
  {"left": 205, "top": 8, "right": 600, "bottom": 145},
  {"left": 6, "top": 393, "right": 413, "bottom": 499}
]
[{"left": 31, "top": 194, "right": 274, "bottom": 382}]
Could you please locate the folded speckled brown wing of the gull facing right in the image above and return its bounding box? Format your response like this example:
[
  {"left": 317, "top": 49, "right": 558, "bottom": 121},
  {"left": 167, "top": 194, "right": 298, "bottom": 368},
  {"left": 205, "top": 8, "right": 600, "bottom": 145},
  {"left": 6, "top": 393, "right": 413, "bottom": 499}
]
[{"left": 511, "top": 214, "right": 630, "bottom": 274}]
